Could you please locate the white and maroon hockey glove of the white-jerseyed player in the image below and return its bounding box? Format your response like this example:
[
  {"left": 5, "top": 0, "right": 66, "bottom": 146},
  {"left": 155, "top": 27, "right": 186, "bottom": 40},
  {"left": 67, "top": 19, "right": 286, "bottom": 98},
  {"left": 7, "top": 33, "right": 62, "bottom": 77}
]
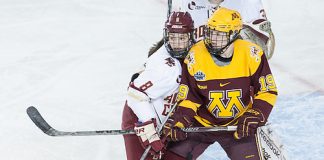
[{"left": 134, "top": 119, "right": 164, "bottom": 154}]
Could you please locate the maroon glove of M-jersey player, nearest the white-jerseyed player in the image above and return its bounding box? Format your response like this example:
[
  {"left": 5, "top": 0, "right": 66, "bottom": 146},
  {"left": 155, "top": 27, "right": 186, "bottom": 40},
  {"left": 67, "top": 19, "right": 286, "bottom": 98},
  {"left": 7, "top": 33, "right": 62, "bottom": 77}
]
[{"left": 162, "top": 116, "right": 192, "bottom": 141}]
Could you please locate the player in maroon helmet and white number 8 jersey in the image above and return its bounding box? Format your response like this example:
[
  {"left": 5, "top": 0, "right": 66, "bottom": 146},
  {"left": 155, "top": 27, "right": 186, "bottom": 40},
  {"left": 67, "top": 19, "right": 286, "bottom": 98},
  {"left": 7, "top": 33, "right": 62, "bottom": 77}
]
[{"left": 122, "top": 12, "right": 194, "bottom": 160}]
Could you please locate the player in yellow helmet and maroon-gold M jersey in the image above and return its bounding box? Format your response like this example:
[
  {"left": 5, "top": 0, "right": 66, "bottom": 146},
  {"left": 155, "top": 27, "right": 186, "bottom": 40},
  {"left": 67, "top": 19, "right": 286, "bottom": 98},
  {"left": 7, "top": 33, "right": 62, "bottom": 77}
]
[{"left": 163, "top": 7, "right": 277, "bottom": 160}]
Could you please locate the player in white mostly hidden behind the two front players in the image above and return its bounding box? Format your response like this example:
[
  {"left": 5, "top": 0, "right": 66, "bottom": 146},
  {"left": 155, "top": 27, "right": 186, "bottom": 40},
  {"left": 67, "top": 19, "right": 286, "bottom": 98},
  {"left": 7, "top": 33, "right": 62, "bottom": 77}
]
[{"left": 149, "top": 0, "right": 275, "bottom": 59}]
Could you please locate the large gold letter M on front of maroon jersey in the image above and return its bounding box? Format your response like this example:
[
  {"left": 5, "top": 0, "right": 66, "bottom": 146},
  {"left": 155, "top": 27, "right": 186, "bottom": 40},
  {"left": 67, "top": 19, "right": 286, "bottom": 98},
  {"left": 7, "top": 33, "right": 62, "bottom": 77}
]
[{"left": 207, "top": 89, "right": 245, "bottom": 118}]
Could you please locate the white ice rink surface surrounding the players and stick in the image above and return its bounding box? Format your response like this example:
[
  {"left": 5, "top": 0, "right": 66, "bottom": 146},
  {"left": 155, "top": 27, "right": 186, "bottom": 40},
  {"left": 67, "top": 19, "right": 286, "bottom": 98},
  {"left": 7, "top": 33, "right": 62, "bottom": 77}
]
[{"left": 0, "top": 0, "right": 324, "bottom": 160}]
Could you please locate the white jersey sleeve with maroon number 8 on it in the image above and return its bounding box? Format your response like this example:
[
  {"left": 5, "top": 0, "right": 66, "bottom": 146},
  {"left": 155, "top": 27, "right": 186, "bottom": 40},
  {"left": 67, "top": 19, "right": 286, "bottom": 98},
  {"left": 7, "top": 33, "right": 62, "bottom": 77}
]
[{"left": 127, "top": 55, "right": 180, "bottom": 122}]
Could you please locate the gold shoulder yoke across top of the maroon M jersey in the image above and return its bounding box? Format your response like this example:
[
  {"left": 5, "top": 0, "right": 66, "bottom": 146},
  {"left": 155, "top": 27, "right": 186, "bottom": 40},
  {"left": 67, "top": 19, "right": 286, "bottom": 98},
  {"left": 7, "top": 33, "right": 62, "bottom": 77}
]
[{"left": 184, "top": 40, "right": 263, "bottom": 81}]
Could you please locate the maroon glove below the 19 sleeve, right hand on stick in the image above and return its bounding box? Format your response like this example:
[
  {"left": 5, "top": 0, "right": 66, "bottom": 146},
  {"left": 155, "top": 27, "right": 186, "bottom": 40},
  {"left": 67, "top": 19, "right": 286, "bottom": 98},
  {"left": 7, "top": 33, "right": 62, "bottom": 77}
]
[{"left": 234, "top": 109, "right": 266, "bottom": 139}]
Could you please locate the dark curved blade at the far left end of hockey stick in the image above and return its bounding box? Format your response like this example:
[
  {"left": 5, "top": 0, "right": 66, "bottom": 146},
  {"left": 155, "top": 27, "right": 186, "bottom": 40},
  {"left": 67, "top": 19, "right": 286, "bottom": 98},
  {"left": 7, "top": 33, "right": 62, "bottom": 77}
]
[{"left": 27, "top": 106, "right": 52, "bottom": 135}]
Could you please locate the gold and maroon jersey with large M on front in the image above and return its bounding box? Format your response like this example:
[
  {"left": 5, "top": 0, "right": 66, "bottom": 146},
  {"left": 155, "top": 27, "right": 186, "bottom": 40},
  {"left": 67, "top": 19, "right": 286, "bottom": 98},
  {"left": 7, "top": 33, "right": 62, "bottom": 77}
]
[{"left": 178, "top": 40, "right": 277, "bottom": 126}]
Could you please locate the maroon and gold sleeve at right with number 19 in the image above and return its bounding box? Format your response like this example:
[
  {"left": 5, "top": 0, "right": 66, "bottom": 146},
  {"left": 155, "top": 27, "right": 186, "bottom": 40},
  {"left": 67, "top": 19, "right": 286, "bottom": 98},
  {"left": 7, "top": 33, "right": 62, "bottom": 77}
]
[{"left": 250, "top": 48, "right": 278, "bottom": 119}]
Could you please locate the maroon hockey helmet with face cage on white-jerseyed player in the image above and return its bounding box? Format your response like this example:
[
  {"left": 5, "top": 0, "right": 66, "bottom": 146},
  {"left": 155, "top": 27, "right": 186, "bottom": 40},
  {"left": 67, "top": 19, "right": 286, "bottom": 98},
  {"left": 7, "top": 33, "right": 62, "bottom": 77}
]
[{"left": 164, "top": 12, "right": 194, "bottom": 58}]
